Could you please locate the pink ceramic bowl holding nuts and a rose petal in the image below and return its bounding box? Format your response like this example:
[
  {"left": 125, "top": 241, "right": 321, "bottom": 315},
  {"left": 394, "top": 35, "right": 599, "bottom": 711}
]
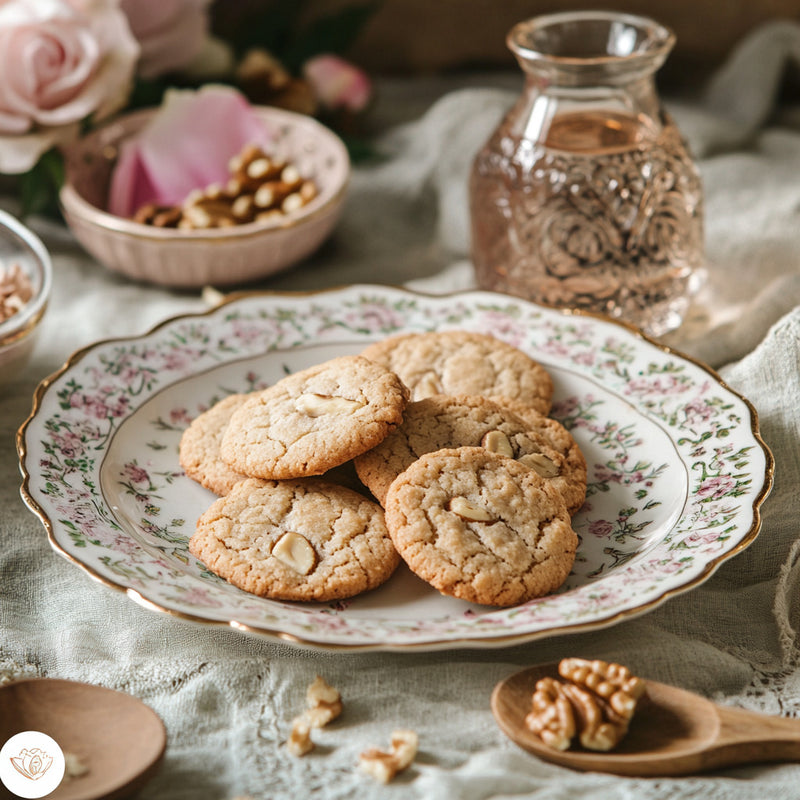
[{"left": 60, "top": 107, "right": 350, "bottom": 288}]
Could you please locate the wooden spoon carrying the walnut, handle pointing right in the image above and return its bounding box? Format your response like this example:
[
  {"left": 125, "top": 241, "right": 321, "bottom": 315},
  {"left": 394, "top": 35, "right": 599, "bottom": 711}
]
[{"left": 492, "top": 664, "right": 800, "bottom": 776}]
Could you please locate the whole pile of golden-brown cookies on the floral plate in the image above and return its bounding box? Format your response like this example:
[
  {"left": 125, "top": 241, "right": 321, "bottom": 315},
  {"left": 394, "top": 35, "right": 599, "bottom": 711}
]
[{"left": 180, "top": 331, "right": 586, "bottom": 606}]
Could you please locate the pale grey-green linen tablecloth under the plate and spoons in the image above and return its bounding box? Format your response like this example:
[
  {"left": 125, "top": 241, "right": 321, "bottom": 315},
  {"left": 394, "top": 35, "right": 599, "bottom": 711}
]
[{"left": 0, "top": 24, "right": 800, "bottom": 800}]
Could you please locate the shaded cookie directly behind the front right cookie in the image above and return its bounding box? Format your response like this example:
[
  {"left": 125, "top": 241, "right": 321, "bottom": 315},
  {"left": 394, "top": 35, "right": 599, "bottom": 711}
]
[{"left": 355, "top": 395, "right": 586, "bottom": 513}]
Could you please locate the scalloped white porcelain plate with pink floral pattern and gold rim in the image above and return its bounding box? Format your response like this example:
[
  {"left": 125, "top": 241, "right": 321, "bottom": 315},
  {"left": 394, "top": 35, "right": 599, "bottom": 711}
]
[{"left": 17, "top": 286, "right": 773, "bottom": 650}]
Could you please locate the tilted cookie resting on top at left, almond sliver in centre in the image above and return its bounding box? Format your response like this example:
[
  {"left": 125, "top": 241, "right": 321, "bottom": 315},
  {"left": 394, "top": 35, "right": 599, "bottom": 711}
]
[{"left": 220, "top": 356, "right": 408, "bottom": 479}]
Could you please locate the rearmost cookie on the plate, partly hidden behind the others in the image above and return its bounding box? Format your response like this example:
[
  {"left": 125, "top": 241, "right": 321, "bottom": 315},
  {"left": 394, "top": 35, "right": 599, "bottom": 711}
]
[{"left": 362, "top": 330, "right": 553, "bottom": 414}]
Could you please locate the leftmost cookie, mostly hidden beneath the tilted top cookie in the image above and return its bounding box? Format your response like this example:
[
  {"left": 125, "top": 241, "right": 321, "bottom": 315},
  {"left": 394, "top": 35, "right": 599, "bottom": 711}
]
[{"left": 178, "top": 393, "right": 252, "bottom": 495}]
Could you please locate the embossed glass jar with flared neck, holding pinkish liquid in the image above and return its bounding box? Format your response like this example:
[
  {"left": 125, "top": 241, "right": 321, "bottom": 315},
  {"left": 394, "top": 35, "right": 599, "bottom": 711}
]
[{"left": 470, "top": 11, "right": 703, "bottom": 335}]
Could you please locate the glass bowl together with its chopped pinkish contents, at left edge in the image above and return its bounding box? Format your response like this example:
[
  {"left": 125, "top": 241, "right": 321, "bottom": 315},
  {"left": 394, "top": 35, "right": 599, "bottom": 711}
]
[{"left": 0, "top": 211, "right": 53, "bottom": 391}]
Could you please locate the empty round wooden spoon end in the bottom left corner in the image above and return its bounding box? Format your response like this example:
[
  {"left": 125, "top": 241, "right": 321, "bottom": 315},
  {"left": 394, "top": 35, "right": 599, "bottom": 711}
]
[{"left": 0, "top": 678, "right": 167, "bottom": 800}]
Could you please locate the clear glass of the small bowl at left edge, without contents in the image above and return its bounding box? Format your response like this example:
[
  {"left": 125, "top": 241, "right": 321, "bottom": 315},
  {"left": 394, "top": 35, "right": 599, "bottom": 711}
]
[{"left": 0, "top": 210, "right": 53, "bottom": 390}]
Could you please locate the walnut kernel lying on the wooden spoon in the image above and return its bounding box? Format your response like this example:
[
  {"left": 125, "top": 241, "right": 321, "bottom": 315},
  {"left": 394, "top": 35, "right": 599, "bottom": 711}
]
[{"left": 525, "top": 658, "right": 646, "bottom": 752}]
